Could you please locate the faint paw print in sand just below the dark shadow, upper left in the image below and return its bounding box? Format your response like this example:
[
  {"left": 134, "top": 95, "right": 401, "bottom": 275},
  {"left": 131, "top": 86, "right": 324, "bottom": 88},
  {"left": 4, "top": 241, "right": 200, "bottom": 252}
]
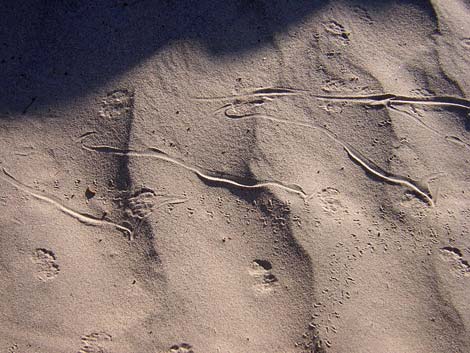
[{"left": 99, "top": 89, "right": 134, "bottom": 119}]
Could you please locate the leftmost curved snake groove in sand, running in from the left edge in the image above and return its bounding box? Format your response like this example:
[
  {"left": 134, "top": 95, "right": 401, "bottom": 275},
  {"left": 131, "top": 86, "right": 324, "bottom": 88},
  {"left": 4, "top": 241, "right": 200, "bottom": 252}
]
[{"left": 0, "top": 168, "right": 132, "bottom": 238}]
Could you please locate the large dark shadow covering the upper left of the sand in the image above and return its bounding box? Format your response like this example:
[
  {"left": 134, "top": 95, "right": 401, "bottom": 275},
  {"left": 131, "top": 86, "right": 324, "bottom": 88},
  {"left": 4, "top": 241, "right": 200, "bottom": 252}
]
[{"left": 0, "top": 0, "right": 328, "bottom": 118}]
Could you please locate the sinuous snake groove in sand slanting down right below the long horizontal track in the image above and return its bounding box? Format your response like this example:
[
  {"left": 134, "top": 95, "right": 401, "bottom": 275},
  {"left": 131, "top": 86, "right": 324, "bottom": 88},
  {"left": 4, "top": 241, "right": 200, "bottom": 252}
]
[{"left": 218, "top": 108, "right": 434, "bottom": 206}]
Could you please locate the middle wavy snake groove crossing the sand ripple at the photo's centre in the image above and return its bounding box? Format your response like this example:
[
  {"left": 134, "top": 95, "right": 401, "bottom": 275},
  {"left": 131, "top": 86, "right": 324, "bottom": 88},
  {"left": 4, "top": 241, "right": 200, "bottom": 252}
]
[{"left": 82, "top": 145, "right": 307, "bottom": 199}]
